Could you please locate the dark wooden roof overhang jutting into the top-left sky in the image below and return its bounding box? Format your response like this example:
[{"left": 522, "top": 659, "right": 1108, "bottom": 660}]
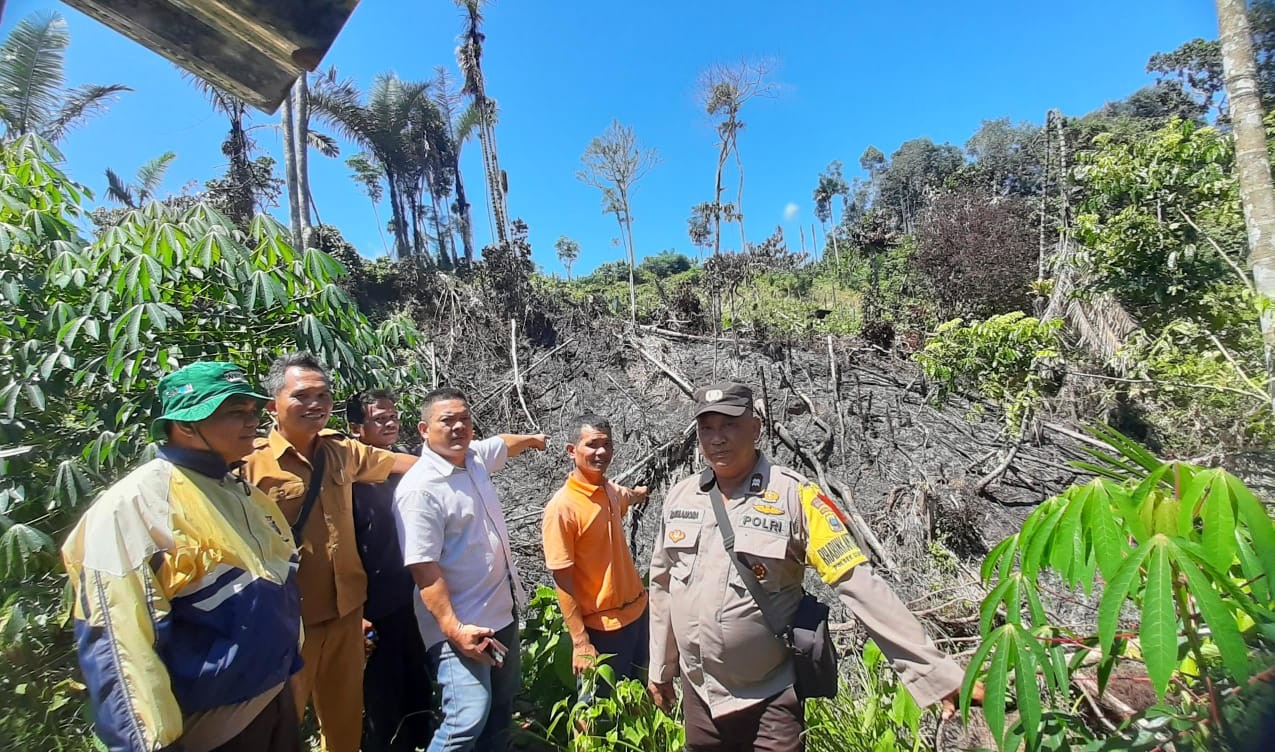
[{"left": 64, "top": 0, "right": 358, "bottom": 112}]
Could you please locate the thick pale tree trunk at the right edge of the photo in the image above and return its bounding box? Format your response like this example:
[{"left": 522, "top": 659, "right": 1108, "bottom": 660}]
[{"left": 1218, "top": 0, "right": 1275, "bottom": 393}]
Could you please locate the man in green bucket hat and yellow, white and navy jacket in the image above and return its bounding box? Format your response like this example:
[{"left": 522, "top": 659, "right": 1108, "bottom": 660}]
[{"left": 62, "top": 362, "right": 301, "bottom": 752}]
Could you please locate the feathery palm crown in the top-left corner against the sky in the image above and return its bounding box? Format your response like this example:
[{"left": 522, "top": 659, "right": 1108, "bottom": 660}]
[{"left": 0, "top": 13, "right": 133, "bottom": 143}]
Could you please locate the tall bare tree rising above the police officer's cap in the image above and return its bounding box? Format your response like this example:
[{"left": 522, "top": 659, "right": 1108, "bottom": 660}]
[{"left": 697, "top": 59, "right": 778, "bottom": 256}]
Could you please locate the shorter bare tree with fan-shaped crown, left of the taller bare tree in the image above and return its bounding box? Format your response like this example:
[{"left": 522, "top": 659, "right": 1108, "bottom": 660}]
[{"left": 575, "top": 120, "right": 659, "bottom": 321}]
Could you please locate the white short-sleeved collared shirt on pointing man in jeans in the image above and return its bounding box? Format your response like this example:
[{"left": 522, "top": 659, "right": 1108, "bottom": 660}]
[{"left": 394, "top": 436, "right": 525, "bottom": 647}]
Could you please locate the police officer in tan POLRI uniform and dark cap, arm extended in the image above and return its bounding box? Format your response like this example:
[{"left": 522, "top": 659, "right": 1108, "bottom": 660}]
[{"left": 649, "top": 384, "right": 964, "bottom": 752}]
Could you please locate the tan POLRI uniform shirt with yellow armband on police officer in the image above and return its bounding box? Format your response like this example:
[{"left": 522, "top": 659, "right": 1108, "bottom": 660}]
[{"left": 650, "top": 455, "right": 964, "bottom": 718}]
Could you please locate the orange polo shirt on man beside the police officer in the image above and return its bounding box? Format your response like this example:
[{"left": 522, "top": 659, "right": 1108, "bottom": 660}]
[{"left": 543, "top": 475, "right": 646, "bottom": 632}]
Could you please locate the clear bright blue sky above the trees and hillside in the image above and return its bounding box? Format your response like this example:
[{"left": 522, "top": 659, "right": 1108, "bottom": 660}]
[{"left": 0, "top": 0, "right": 1216, "bottom": 273}]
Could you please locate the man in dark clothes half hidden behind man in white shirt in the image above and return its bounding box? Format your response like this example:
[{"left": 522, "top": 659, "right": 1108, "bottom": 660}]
[{"left": 346, "top": 390, "right": 434, "bottom": 752}]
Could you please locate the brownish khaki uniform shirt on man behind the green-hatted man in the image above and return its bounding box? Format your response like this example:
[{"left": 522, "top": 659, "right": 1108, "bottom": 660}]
[{"left": 244, "top": 428, "right": 394, "bottom": 625}]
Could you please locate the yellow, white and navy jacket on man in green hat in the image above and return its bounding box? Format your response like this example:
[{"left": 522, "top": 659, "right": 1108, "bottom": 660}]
[{"left": 62, "top": 446, "right": 301, "bottom": 752}]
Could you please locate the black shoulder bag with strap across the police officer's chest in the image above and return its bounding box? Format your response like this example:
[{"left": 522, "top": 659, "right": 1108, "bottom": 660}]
[{"left": 709, "top": 484, "right": 838, "bottom": 700}]
